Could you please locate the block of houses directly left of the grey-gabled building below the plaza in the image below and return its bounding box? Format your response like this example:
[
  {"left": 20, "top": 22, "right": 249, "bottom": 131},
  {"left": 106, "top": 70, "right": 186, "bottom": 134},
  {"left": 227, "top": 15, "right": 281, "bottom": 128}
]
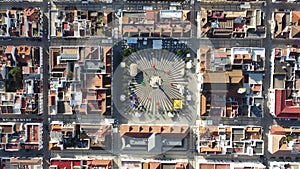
[{"left": 49, "top": 121, "right": 112, "bottom": 150}]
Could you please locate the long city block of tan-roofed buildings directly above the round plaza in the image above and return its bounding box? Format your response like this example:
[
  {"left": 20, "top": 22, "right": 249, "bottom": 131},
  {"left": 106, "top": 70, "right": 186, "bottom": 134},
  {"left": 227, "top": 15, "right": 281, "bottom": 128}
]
[{"left": 122, "top": 10, "right": 192, "bottom": 37}]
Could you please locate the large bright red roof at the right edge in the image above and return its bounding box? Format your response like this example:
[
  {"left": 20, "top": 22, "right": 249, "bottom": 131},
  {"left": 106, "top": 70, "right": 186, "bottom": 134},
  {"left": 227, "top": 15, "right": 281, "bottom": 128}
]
[{"left": 275, "top": 90, "right": 300, "bottom": 118}]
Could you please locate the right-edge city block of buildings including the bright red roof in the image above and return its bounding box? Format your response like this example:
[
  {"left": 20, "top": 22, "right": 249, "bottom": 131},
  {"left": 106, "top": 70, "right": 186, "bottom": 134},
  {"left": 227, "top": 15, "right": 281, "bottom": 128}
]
[{"left": 269, "top": 46, "right": 300, "bottom": 119}]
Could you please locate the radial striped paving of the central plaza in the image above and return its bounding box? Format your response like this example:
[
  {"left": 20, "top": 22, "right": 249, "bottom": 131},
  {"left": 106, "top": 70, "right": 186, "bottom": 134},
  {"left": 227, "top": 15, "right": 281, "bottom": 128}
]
[{"left": 126, "top": 50, "right": 186, "bottom": 113}]
